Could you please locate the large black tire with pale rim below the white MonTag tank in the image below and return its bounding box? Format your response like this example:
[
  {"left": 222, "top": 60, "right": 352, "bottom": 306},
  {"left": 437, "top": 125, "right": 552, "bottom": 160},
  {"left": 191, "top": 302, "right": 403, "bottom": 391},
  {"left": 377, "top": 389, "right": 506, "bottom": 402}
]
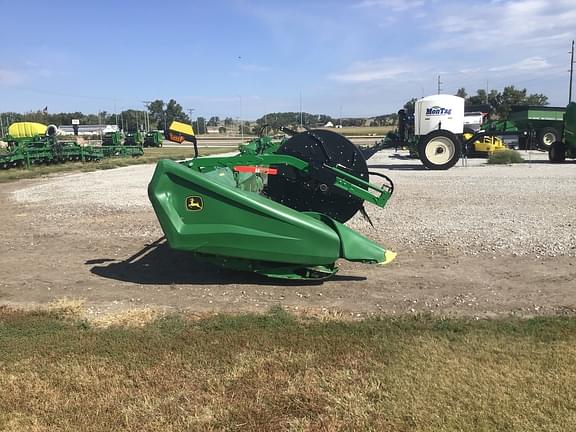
[{"left": 418, "top": 130, "right": 462, "bottom": 170}]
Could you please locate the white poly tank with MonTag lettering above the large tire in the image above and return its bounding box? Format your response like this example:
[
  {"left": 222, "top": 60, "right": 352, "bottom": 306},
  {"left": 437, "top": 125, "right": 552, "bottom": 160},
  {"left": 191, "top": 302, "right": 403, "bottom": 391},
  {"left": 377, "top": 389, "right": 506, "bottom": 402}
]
[{"left": 414, "top": 95, "right": 464, "bottom": 135}]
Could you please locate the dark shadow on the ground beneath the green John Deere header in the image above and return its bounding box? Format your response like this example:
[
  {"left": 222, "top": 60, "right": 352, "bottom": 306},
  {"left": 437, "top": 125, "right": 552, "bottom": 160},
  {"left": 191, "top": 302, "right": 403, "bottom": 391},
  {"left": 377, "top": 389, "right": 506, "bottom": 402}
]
[{"left": 85, "top": 237, "right": 366, "bottom": 286}]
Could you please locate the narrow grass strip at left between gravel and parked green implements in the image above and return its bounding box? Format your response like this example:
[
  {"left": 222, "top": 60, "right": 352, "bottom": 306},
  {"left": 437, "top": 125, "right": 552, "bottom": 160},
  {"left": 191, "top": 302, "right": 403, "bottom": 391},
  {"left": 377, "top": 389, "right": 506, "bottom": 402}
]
[{"left": 0, "top": 147, "right": 231, "bottom": 183}]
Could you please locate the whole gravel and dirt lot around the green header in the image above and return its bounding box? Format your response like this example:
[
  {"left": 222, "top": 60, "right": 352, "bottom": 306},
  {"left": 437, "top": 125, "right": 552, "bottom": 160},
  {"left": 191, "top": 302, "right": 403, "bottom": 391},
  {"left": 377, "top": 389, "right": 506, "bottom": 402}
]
[{"left": 0, "top": 151, "right": 576, "bottom": 316}]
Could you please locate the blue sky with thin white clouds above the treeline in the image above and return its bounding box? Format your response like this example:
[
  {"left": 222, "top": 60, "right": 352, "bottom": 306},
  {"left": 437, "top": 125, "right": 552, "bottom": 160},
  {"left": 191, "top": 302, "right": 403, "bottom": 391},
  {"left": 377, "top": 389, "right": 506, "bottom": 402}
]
[{"left": 0, "top": 0, "right": 576, "bottom": 119}]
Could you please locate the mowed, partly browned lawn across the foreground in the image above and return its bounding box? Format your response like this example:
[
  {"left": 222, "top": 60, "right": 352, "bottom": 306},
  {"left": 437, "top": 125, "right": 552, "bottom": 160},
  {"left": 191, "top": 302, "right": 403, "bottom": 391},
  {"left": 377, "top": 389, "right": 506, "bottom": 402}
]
[{"left": 0, "top": 308, "right": 576, "bottom": 432}]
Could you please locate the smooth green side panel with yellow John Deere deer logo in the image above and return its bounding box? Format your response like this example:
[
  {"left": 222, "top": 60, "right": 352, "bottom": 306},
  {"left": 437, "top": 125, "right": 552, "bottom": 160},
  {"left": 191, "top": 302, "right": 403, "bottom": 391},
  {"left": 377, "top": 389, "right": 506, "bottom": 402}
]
[{"left": 148, "top": 160, "right": 340, "bottom": 265}]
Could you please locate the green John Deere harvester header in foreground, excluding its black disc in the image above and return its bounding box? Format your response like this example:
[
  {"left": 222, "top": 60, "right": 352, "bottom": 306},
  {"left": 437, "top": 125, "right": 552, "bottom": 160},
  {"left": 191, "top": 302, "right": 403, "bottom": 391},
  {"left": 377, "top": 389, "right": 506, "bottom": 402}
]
[{"left": 148, "top": 131, "right": 396, "bottom": 280}]
